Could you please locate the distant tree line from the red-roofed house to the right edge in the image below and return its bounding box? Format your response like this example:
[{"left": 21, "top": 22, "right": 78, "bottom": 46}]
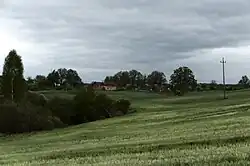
[{"left": 104, "top": 66, "right": 250, "bottom": 95}]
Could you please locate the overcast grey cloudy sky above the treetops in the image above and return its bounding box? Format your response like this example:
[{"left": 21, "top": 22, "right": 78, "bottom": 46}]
[{"left": 0, "top": 0, "right": 250, "bottom": 83}]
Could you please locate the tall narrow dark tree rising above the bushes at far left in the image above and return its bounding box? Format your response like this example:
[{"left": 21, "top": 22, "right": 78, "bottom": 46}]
[{"left": 2, "top": 50, "right": 25, "bottom": 101}]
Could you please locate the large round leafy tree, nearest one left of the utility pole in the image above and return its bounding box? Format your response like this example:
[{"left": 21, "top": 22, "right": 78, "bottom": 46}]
[{"left": 170, "top": 66, "right": 197, "bottom": 95}]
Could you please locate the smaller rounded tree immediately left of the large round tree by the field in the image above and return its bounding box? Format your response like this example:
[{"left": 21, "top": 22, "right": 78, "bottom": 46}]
[{"left": 147, "top": 71, "right": 167, "bottom": 88}]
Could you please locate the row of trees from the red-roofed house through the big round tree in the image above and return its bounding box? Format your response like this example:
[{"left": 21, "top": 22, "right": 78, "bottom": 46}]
[{"left": 104, "top": 66, "right": 197, "bottom": 95}]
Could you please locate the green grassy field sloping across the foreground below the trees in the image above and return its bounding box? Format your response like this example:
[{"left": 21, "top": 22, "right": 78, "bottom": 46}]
[{"left": 0, "top": 91, "right": 250, "bottom": 166}]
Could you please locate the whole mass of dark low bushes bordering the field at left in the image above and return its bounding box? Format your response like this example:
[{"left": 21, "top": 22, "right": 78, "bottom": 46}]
[{"left": 0, "top": 87, "right": 131, "bottom": 134}]
